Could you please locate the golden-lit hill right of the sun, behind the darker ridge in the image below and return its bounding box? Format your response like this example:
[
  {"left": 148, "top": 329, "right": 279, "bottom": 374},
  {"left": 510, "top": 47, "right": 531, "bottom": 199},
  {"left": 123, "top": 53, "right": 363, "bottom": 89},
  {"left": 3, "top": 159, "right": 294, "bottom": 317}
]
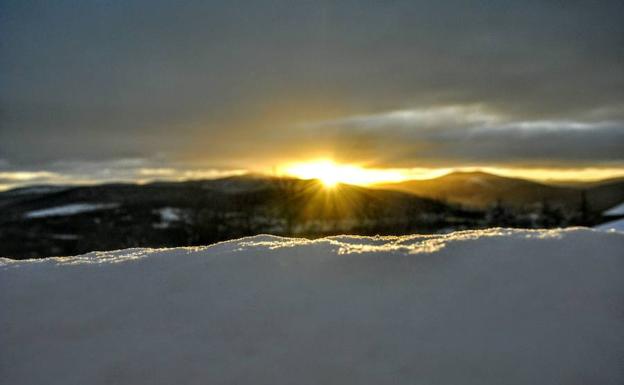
[{"left": 377, "top": 172, "right": 624, "bottom": 211}]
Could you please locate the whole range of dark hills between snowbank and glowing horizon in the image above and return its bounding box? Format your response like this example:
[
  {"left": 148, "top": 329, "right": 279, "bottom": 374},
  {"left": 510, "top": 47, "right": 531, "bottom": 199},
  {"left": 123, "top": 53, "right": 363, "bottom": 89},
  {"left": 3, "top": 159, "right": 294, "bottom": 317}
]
[{"left": 0, "top": 173, "right": 624, "bottom": 258}]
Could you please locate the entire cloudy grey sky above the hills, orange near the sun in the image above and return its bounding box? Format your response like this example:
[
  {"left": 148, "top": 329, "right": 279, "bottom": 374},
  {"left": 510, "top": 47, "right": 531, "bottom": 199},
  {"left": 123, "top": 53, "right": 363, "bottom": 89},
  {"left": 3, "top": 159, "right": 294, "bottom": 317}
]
[{"left": 0, "top": 0, "right": 624, "bottom": 188}]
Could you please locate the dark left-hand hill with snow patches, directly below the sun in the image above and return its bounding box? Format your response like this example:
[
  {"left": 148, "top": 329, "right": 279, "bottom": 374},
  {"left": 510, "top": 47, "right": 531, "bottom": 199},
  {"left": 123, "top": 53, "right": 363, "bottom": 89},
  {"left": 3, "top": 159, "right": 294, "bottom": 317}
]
[{"left": 0, "top": 175, "right": 464, "bottom": 258}]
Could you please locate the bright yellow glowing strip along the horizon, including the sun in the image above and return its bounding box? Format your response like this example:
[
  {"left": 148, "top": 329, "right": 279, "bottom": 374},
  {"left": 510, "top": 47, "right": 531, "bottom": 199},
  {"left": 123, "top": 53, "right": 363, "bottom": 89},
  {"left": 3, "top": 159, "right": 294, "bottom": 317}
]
[{"left": 0, "top": 158, "right": 624, "bottom": 191}]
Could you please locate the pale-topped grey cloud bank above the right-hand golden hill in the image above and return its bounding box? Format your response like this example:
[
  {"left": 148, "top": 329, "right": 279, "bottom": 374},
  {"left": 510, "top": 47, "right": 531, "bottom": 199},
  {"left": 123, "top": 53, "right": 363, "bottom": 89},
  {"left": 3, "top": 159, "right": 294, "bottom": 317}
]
[{"left": 304, "top": 105, "right": 624, "bottom": 166}]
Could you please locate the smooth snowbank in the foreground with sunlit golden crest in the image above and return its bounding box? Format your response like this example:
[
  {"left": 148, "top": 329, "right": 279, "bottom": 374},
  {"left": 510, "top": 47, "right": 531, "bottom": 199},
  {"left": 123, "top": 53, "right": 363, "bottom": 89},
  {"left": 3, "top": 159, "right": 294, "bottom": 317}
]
[{"left": 0, "top": 229, "right": 624, "bottom": 385}]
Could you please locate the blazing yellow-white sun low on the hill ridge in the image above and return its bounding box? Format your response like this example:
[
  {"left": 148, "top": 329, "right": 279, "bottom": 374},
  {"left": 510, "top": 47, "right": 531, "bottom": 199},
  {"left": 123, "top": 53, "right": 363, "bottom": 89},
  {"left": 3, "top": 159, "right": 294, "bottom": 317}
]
[{"left": 282, "top": 159, "right": 402, "bottom": 188}]
